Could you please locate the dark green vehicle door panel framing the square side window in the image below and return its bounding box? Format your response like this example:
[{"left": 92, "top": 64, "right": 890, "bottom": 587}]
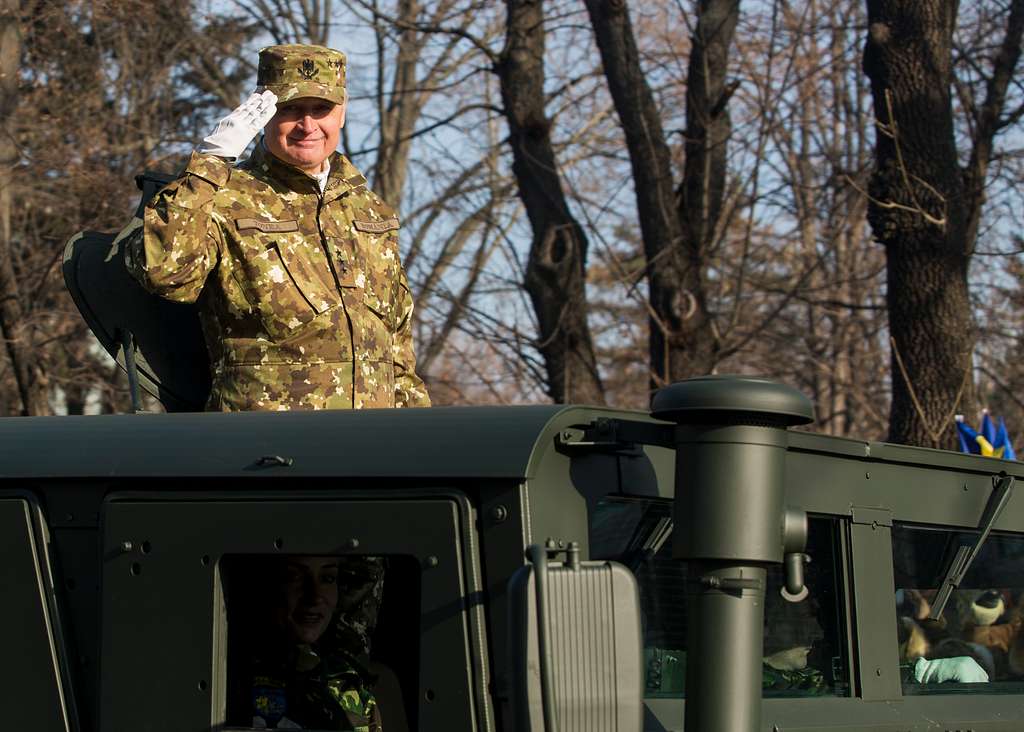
[{"left": 99, "top": 493, "right": 493, "bottom": 732}]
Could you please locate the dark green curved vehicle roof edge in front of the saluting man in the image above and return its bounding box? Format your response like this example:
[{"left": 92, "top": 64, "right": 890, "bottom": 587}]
[{"left": 0, "top": 405, "right": 649, "bottom": 479}]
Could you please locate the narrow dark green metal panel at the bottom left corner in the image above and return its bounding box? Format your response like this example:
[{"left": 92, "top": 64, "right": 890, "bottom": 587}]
[{"left": 0, "top": 498, "right": 72, "bottom": 732}]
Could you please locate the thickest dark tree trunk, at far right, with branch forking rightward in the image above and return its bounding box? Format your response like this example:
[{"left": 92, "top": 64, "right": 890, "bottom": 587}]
[{"left": 864, "top": 0, "right": 1024, "bottom": 448}]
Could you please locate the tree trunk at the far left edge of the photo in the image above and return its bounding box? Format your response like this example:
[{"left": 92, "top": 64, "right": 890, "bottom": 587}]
[{"left": 0, "top": 0, "right": 49, "bottom": 415}]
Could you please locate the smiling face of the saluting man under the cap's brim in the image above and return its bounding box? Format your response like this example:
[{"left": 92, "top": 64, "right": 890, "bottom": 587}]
[{"left": 263, "top": 96, "right": 345, "bottom": 173}]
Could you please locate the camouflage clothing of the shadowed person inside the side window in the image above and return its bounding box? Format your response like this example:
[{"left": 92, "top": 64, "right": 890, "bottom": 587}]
[{"left": 252, "top": 646, "right": 383, "bottom": 732}]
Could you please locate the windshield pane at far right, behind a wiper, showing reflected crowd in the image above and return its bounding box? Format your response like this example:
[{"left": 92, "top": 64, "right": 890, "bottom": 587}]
[{"left": 893, "top": 524, "right": 1024, "bottom": 694}]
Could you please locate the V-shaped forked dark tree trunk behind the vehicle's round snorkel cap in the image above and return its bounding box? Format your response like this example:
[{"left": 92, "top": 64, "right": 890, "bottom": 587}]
[{"left": 587, "top": 0, "right": 739, "bottom": 388}]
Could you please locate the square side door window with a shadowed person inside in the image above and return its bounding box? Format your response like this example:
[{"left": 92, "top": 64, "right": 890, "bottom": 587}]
[{"left": 221, "top": 555, "right": 420, "bottom": 730}]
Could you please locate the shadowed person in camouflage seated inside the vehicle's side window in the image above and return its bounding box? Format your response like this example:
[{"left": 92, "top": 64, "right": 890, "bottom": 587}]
[{"left": 240, "top": 556, "right": 387, "bottom": 732}]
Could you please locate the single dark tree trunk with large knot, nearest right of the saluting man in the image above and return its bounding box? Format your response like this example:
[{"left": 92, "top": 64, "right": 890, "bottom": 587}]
[{"left": 497, "top": 0, "right": 604, "bottom": 403}]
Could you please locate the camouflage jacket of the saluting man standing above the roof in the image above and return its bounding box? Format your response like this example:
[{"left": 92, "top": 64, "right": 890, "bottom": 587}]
[{"left": 126, "top": 141, "right": 430, "bottom": 412}]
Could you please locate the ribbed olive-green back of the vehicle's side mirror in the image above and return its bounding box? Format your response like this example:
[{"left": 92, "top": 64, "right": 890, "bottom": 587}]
[{"left": 508, "top": 542, "right": 643, "bottom": 732}]
